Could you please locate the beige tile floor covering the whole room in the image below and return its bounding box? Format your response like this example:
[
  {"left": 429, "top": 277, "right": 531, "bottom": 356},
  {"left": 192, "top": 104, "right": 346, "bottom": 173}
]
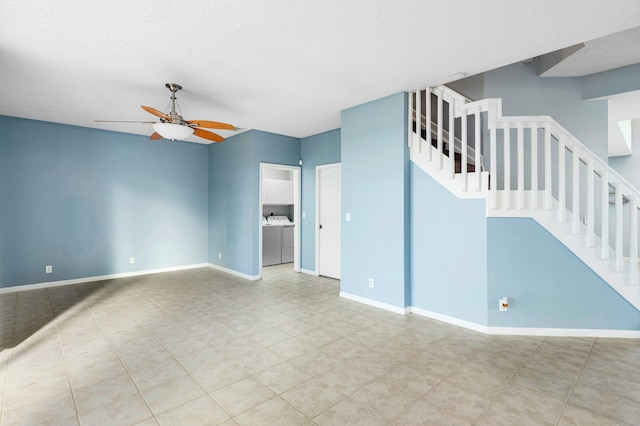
[{"left": 0, "top": 264, "right": 640, "bottom": 426}]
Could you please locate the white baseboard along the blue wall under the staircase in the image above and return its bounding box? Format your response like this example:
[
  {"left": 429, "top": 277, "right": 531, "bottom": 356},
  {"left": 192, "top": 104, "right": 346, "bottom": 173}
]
[{"left": 407, "top": 306, "right": 640, "bottom": 339}]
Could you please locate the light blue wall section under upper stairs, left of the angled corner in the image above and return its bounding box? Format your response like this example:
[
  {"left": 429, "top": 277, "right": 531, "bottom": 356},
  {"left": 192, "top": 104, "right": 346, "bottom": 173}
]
[{"left": 411, "top": 164, "right": 487, "bottom": 325}]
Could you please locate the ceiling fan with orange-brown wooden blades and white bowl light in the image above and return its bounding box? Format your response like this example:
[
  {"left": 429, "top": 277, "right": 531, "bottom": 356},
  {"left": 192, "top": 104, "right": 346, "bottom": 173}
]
[{"left": 94, "top": 83, "right": 237, "bottom": 142}]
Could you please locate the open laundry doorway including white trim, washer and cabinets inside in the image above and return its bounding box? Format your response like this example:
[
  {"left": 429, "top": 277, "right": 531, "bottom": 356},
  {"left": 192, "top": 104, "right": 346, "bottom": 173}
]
[{"left": 258, "top": 163, "right": 301, "bottom": 277}]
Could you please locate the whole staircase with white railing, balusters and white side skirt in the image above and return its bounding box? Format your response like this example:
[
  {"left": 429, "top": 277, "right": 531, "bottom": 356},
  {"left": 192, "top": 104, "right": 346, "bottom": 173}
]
[{"left": 408, "top": 86, "right": 640, "bottom": 310}]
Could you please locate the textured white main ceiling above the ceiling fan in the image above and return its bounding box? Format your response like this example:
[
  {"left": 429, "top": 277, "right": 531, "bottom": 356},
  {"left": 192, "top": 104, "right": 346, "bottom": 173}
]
[{"left": 0, "top": 0, "right": 640, "bottom": 142}]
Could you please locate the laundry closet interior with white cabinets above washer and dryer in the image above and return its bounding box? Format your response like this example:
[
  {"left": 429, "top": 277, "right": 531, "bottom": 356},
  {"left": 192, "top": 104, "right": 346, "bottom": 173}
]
[{"left": 262, "top": 169, "right": 295, "bottom": 266}]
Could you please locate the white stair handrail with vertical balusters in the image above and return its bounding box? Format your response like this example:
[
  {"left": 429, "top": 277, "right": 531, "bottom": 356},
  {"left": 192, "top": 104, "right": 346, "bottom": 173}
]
[{"left": 409, "top": 86, "right": 640, "bottom": 285}]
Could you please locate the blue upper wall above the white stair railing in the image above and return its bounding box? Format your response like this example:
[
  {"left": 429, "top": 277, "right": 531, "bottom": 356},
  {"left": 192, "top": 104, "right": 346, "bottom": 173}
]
[{"left": 484, "top": 63, "right": 608, "bottom": 161}]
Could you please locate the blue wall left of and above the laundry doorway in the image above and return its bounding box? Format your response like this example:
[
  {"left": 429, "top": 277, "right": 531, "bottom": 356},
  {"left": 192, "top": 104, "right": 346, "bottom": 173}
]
[{"left": 208, "top": 130, "right": 300, "bottom": 276}]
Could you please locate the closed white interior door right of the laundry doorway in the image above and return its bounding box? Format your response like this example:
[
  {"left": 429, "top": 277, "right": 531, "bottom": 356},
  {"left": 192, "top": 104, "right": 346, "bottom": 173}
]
[{"left": 316, "top": 164, "right": 341, "bottom": 279}]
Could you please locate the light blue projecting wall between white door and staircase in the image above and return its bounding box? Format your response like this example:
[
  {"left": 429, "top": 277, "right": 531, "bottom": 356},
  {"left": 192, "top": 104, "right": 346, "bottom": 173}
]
[{"left": 341, "top": 93, "right": 410, "bottom": 308}]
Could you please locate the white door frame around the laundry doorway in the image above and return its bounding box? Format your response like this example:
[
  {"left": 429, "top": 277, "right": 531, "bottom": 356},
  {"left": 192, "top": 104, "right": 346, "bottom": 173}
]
[{"left": 257, "top": 162, "right": 302, "bottom": 278}]
